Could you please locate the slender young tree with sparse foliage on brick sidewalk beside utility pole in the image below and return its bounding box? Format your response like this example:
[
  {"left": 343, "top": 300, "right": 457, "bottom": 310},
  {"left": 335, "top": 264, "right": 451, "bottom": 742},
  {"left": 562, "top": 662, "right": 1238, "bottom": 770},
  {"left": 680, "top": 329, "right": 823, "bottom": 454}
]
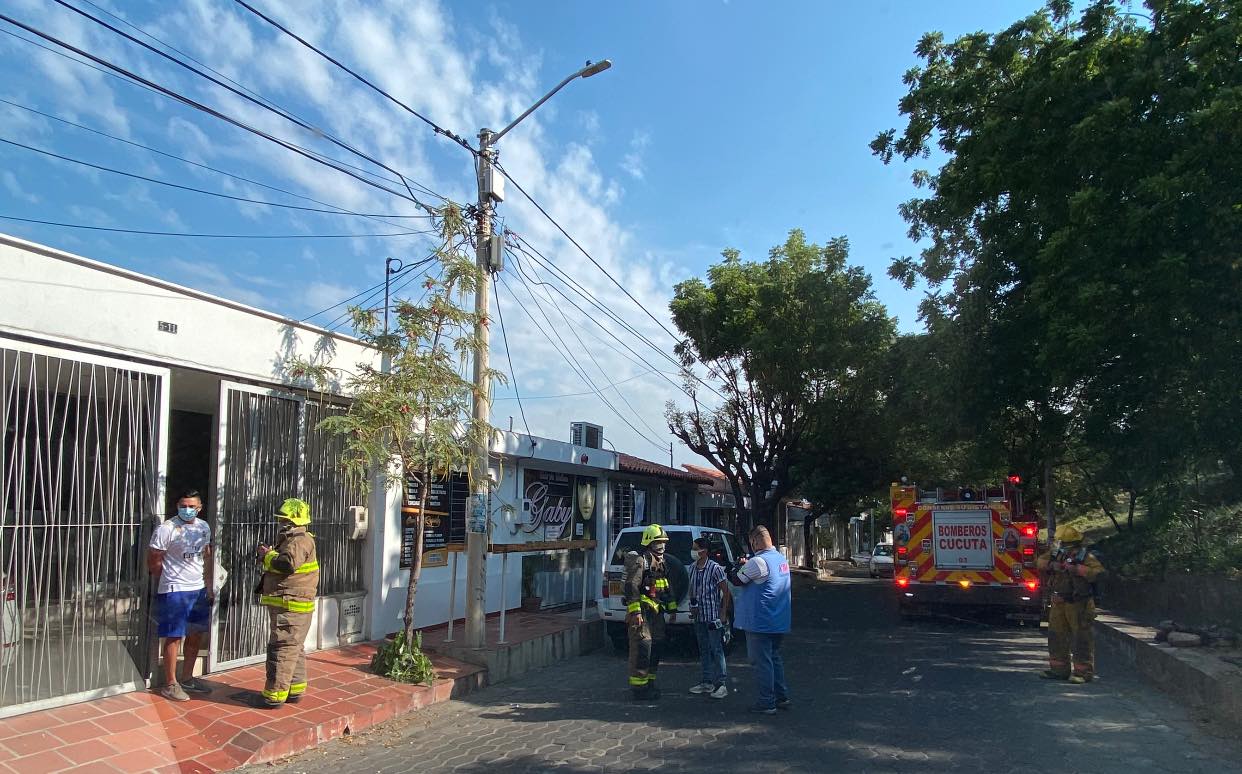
[{"left": 293, "top": 204, "right": 504, "bottom": 644}]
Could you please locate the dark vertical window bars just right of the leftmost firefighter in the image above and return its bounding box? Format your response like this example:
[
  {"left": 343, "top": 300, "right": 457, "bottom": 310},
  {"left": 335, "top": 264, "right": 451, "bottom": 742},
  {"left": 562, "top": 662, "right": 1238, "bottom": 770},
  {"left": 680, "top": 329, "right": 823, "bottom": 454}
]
[{"left": 303, "top": 401, "right": 365, "bottom": 596}]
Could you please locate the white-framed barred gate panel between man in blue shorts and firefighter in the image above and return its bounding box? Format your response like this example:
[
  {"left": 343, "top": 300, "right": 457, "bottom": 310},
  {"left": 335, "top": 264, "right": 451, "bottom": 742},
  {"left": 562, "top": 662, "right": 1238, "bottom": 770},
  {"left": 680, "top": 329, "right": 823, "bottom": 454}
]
[{"left": 212, "top": 384, "right": 302, "bottom": 668}]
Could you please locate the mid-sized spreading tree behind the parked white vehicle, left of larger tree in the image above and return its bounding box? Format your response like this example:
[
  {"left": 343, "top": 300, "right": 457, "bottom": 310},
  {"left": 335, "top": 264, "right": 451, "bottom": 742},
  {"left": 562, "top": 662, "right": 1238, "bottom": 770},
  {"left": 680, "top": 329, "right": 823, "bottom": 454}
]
[{"left": 667, "top": 230, "right": 894, "bottom": 529}]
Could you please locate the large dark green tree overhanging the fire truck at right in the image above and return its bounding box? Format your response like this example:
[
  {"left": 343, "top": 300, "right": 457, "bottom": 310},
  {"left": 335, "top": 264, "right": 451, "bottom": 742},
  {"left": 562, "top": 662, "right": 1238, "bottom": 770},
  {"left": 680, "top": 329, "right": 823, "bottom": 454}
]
[{"left": 872, "top": 0, "right": 1242, "bottom": 526}]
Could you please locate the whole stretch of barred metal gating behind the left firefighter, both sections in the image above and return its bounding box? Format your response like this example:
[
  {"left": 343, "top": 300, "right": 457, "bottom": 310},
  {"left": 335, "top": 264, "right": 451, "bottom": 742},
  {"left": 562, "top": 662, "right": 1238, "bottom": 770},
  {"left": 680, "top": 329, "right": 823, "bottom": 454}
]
[{"left": 210, "top": 381, "right": 363, "bottom": 670}]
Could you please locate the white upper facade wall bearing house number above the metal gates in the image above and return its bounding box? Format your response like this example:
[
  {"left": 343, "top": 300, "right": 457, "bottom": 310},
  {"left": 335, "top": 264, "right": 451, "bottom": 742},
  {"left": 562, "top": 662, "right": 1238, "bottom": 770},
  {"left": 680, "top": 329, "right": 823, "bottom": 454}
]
[{"left": 0, "top": 235, "right": 378, "bottom": 391}]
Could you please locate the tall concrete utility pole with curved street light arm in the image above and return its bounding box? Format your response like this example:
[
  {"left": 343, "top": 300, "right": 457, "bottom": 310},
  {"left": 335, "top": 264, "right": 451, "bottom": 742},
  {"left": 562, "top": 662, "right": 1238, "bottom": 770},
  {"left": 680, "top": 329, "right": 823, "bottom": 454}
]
[{"left": 466, "top": 60, "right": 612, "bottom": 649}]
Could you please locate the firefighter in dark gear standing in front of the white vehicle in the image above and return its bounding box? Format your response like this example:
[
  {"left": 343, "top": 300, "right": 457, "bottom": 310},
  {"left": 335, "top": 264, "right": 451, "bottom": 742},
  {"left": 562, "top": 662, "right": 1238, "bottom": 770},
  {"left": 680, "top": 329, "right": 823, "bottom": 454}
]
[{"left": 622, "top": 524, "right": 677, "bottom": 701}]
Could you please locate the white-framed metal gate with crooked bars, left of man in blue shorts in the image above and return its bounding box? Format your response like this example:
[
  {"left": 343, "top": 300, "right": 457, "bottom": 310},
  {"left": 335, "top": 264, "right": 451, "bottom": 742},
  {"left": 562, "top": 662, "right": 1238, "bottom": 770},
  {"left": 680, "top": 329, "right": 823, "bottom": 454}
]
[{"left": 0, "top": 340, "right": 169, "bottom": 717}]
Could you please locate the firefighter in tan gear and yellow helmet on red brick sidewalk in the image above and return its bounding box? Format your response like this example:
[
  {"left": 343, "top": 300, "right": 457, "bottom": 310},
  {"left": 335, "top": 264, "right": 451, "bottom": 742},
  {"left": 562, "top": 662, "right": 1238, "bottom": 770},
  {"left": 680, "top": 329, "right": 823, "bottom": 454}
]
[{"left": 255, "top": 498, "right": 319, "bottom": 709}]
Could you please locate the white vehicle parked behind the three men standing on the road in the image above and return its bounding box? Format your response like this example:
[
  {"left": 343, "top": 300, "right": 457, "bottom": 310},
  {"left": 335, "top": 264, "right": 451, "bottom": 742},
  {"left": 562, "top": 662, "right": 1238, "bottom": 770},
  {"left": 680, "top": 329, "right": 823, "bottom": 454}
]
[{"left": 596, "top": 524, "right": 744, "bottom": 651}]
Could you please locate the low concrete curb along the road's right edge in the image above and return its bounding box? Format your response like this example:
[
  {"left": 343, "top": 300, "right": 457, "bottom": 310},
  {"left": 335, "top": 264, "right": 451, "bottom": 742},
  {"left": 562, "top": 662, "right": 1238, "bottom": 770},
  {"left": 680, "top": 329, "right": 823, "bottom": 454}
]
[{"left": 1095, "top": 612, "right": 1242, "bottom": 727}]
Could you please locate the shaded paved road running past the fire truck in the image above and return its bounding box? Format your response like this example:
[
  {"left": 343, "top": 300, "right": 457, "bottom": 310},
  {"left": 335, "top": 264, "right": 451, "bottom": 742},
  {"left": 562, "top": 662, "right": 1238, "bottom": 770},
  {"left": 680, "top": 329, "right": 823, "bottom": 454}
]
[{"left": 247, "top": 579, "right": 1242, "bottom": 774}]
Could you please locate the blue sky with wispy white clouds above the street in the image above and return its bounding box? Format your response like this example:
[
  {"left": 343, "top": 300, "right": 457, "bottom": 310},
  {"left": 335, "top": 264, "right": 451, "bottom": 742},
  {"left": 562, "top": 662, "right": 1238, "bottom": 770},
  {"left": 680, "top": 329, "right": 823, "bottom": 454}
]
[{"left": 0, "top": 0, "right": 1041, "bottom": 465}]
